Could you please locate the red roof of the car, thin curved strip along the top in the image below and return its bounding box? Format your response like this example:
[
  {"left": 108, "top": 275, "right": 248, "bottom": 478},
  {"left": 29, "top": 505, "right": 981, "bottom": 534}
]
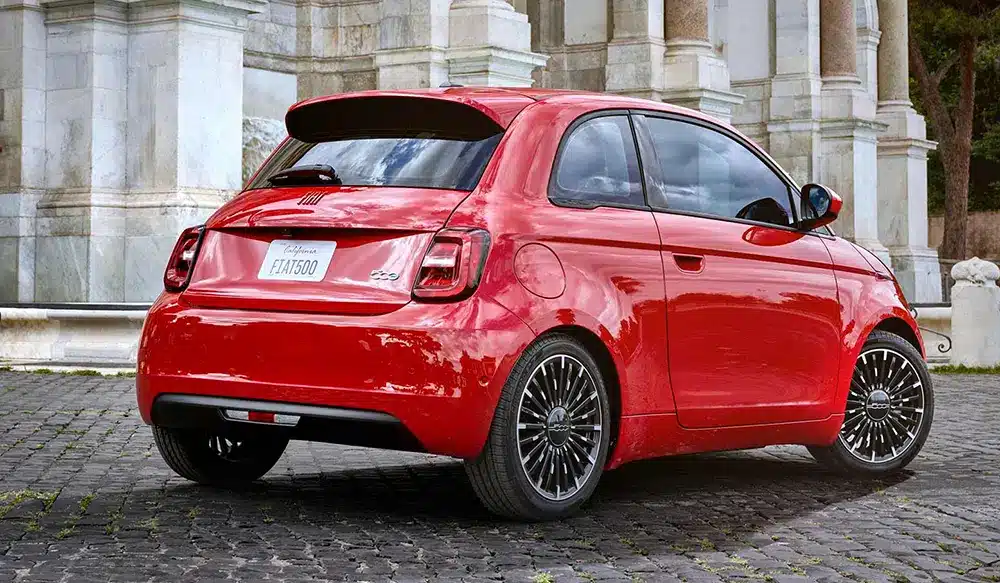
[{"left": 289, "top": 87, "right": 728, "bottom": 129}]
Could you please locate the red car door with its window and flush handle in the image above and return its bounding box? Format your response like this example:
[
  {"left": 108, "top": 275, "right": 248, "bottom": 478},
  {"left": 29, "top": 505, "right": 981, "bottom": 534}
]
[{"left": 633, "top": 113, "right": 841, "bottom": 428}]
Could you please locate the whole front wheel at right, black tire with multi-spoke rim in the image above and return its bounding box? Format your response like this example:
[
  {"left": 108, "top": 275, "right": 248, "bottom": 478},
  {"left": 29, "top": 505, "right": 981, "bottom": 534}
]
[{"left": 809, "top": 330, "right": 934, "bottom": 477}]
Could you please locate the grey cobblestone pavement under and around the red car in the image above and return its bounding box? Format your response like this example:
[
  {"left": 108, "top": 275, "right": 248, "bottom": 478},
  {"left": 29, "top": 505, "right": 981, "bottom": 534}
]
[{"left": 0, "top": 372, "right": 1000, "bottom": 583}]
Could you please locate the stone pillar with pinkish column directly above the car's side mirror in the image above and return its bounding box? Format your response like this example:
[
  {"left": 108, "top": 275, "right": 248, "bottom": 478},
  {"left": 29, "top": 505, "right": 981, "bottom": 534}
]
[{"left": 820, "top": 0, "right": 889, "bottom": 262}]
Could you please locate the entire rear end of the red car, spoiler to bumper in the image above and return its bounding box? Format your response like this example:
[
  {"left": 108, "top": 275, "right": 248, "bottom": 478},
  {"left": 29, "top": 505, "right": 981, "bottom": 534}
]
[{"left": 137, "top": 92, "right": 531, "bottom": 457}]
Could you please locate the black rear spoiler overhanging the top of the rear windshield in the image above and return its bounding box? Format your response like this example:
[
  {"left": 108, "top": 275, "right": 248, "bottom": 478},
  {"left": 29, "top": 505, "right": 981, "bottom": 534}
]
[{"left": 285, "top": 92, "right": 512, "bottom": 143}]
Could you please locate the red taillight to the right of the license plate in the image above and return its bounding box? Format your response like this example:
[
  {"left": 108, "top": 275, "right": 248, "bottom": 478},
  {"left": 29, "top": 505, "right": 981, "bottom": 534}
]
[{"left": 413, "top": 229, "right": 490, "bottom": 300}]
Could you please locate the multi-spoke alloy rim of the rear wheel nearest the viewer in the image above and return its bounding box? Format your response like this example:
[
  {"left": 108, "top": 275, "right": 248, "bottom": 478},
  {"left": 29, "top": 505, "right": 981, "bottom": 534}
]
[{"left": 517, "top": 354, "right": 606, "bottom": 501}]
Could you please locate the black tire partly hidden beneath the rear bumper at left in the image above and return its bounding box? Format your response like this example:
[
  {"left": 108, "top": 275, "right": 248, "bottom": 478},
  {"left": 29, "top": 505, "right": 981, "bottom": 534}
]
[{"left": 153, "top": 426, "right": 288, "bottom": 487}]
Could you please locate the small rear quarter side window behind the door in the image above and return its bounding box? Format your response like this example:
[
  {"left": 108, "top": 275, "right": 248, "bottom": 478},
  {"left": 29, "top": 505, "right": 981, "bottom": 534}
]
[{"left": 549, "top": 115, "right": 645, "bottom": 206}]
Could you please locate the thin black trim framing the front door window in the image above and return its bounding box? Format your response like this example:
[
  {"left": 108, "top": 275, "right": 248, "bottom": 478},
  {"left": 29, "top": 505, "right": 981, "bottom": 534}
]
[{"left": 629, "top": 109, "right": 837, "bottom": 239}]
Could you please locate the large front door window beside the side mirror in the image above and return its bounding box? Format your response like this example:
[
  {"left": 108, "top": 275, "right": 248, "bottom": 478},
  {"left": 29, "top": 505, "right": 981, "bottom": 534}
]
[{"left": 645, "top": 117, "right": 794, "bottom": 226}]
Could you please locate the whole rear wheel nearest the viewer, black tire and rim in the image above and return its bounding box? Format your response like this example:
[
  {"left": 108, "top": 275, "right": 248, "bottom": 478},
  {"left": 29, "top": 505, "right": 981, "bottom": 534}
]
[{"left": 465, "top": 334, "right": 613, "bottom": 520}]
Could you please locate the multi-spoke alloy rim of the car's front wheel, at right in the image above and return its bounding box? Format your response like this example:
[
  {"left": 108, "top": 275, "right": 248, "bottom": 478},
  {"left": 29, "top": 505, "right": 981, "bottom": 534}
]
[{"left": 839, "top": 348, "right": 926, "bottom": 464}]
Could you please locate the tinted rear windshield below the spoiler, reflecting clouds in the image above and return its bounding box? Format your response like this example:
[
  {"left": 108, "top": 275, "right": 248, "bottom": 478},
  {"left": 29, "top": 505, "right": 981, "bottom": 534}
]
[{"left": 247, "top": 133, "right": 503, "bottom": 190}]
